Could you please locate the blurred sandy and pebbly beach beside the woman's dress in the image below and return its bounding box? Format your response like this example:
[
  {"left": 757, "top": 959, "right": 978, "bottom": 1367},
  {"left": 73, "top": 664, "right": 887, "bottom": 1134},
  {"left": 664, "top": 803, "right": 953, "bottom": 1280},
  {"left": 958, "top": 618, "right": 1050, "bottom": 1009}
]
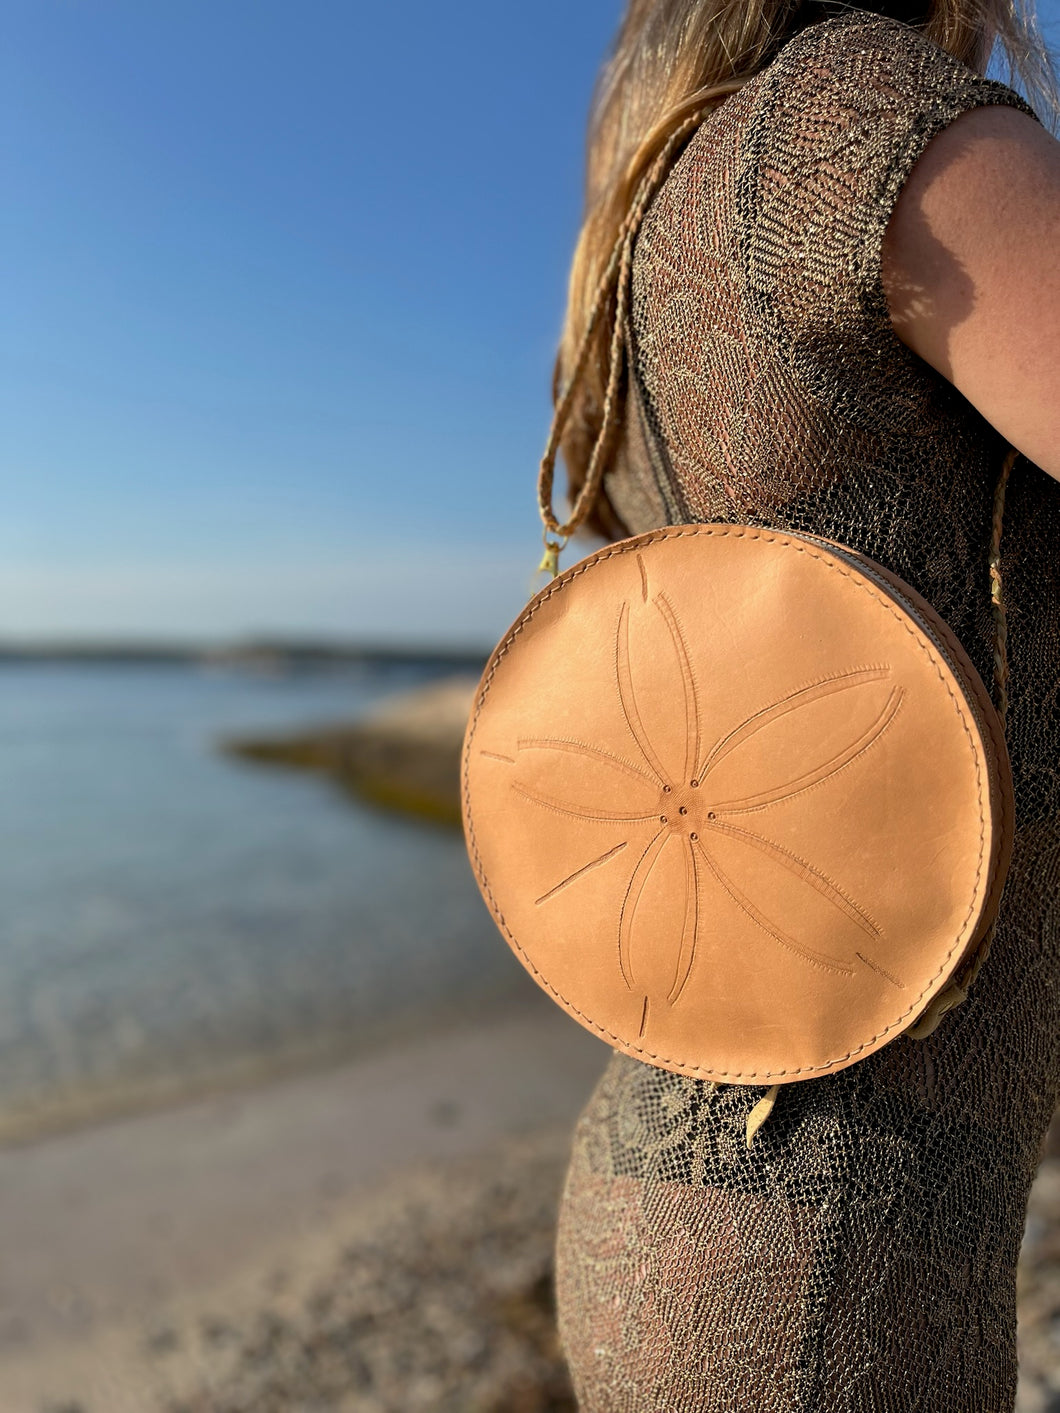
[{"left": 0, "top": 995, "right": 1060, "bottom": 1413}]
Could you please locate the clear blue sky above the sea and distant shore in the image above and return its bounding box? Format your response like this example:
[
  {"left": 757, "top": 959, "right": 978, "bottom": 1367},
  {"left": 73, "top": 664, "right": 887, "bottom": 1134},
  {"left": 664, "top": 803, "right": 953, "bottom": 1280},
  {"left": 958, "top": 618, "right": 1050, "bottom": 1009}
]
[{"left": 0, "top": 0, "right": 1060, "bottom": 644}]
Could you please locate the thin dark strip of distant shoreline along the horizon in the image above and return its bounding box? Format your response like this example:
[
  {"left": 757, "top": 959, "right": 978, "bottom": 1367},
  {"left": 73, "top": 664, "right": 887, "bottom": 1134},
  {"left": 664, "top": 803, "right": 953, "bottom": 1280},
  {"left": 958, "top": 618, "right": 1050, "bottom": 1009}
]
[{"left": 0, "top": 639, "right": 489, "bottom": 671}]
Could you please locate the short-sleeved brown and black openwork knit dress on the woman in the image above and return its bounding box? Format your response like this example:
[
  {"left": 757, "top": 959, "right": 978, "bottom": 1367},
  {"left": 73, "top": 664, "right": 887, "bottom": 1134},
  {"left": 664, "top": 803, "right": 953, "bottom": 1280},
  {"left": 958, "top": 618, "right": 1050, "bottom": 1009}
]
[{"left": 557, "top": 10, "right": 1060, "bottom": 1413}]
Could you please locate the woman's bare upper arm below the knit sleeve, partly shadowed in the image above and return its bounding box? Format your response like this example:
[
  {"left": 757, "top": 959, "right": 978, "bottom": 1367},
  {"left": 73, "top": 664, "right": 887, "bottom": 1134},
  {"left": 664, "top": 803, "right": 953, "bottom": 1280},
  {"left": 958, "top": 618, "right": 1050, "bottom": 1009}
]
[{"left": 882, "top": 107, "right": 1060, "bottom": 479}]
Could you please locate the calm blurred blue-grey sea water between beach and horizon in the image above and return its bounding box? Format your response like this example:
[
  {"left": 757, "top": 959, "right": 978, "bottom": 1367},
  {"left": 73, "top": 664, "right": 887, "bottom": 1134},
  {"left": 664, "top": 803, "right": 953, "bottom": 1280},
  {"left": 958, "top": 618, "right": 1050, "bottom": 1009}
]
[{"left": 0, "top": 664, "right": 524, "bottom": 1133}]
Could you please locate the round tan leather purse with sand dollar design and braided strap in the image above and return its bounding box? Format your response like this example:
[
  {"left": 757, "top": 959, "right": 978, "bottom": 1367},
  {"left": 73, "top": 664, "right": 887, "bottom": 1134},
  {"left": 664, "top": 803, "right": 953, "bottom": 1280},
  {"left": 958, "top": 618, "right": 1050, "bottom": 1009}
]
[{"left": 462, "top": 115, "right": 1015, "bottom": 1140}]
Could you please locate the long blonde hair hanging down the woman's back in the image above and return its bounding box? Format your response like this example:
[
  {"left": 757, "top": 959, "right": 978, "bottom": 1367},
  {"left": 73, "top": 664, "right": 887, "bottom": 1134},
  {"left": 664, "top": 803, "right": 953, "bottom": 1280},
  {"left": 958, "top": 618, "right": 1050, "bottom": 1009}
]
[{"left": 540, "top": 0, "right": 1059, "bottom": 543}]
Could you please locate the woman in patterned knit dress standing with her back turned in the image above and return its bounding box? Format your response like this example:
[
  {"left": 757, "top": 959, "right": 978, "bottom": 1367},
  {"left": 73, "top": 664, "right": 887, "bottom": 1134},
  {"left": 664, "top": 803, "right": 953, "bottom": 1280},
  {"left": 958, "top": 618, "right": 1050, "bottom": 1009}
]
[{"left": 557, "top": 0, "right": 1060, "bottom": 1413}]
